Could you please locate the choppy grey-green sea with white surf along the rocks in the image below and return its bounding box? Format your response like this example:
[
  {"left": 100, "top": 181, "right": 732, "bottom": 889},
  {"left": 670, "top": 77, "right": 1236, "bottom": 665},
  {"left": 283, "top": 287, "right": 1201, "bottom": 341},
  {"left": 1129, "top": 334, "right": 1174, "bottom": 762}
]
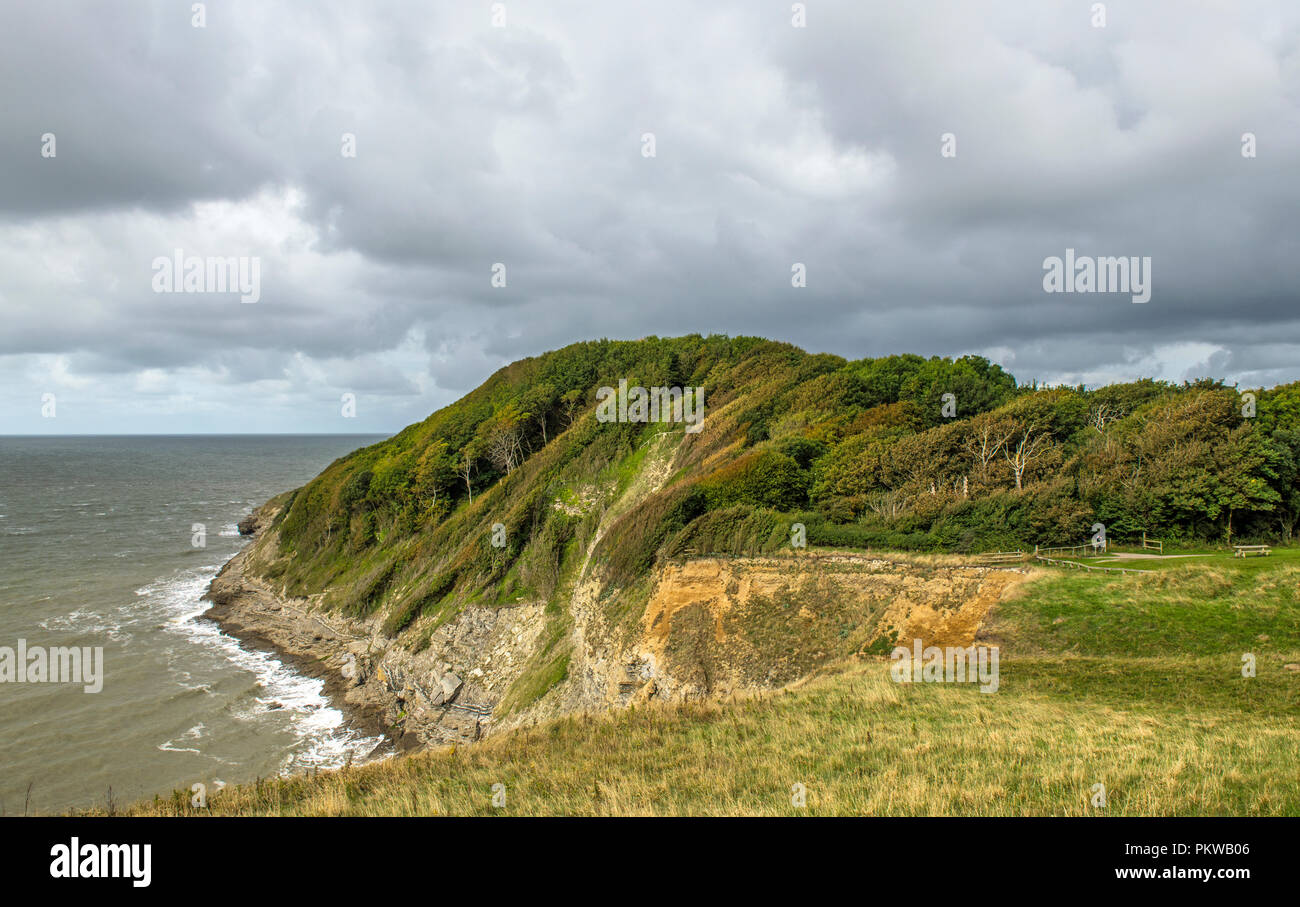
[{"left": 0, "top": 435, "right": 382, "bottom": 816}]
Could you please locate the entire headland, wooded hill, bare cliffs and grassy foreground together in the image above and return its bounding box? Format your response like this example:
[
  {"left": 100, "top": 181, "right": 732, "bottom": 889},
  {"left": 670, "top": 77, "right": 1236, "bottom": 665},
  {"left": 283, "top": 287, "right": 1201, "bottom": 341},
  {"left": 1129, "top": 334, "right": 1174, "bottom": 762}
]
[{"left": 83, "top": 335, "right": 1300, "bottom": 815}]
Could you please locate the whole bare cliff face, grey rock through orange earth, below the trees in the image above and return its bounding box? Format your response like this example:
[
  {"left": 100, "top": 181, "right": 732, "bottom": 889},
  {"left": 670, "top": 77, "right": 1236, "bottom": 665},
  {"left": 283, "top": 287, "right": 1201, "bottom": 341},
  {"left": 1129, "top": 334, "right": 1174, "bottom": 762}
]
[{"left": 208, "top": 480, "right": 1030, "bottom": 748}]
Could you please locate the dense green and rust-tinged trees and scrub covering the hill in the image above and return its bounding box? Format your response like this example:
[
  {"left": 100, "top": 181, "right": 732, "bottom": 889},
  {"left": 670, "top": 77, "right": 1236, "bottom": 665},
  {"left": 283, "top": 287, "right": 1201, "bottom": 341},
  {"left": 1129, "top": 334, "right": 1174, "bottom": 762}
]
[{"left": 250, "top": 337, "right": 1300, "bottom": 657}]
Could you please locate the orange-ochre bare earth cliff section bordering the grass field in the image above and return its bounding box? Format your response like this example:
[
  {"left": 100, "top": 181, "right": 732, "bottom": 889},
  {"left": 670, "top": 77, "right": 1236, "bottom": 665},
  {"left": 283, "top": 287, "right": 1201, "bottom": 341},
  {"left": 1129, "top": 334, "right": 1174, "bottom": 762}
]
[{"left": 636, "top": 554, "right": 1026, "bottom": 698}]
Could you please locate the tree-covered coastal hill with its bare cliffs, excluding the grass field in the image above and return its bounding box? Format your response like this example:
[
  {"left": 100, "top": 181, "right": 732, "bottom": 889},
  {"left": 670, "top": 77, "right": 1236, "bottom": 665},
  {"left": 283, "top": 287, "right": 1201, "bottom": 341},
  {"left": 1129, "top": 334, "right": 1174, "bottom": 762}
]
[{"left": 195, "top": 337, "right": 1300, "bottom": 748}]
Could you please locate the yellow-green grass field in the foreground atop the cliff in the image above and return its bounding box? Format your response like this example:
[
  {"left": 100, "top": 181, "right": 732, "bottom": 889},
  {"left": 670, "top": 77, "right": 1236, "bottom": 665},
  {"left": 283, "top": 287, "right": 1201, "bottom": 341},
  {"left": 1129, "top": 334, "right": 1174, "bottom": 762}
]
[{"left": 98, "top": 548, "right": 1300, "bottom": 816}]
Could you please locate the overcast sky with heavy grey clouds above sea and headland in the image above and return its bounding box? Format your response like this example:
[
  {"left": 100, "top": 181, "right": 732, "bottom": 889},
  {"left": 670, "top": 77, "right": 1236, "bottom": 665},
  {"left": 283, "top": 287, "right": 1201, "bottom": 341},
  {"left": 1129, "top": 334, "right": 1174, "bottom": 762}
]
[{"left": 0, "top": 0, "right": 1300, "bottom": 434}]
